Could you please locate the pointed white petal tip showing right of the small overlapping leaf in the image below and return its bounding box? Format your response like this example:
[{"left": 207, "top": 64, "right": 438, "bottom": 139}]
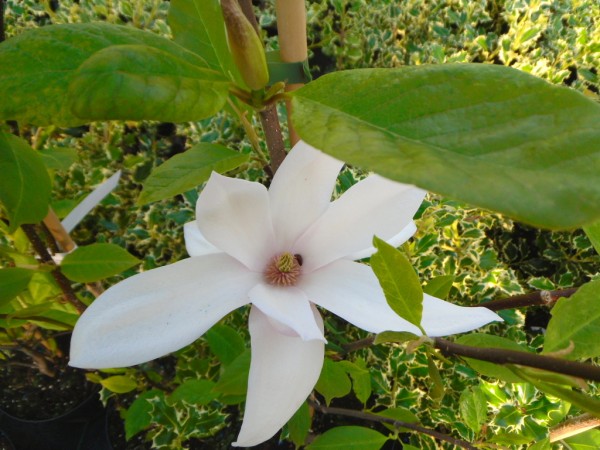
[{"left": 421, "top": 294, "right": 502, "bottom": 337}]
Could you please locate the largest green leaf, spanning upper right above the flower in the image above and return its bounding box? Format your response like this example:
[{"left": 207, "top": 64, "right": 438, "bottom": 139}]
[{"left": 292, "top": 64, "right": 600, "bottom": 228}]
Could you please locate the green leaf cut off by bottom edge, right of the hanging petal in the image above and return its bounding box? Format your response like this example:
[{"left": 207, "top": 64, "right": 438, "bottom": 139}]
[{"left": 306, "top": 426, "right": 388, "bottom": 450}]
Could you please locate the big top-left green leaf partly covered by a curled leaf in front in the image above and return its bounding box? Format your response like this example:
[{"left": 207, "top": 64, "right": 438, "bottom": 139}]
[{"left": 0, "top": 23, "right": 206, "bottom": 126}]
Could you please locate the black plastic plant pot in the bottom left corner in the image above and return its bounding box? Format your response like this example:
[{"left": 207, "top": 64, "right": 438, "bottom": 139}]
[{"left": 0, "top": 392, "right": 113, "bottom": 450}]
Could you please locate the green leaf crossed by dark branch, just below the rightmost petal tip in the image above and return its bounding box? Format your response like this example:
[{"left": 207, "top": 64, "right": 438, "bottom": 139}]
[{"left": 456, "top": 333, "right": 529, "bottom": 383}]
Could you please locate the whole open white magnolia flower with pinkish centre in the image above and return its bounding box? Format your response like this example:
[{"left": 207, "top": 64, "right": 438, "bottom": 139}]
[{"left": 70, "top": 142, "right": 500, "bottom": 446}]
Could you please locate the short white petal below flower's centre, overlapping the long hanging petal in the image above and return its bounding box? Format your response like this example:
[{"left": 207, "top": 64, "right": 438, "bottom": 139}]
[{"left": 248, "top": 283, "right": 325, "bottom": 341}]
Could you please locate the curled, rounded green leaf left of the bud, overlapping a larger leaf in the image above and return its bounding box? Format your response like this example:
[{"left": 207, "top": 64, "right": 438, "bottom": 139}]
[{"left": 68, "top": 45, "right": 229, "bottom": 122}]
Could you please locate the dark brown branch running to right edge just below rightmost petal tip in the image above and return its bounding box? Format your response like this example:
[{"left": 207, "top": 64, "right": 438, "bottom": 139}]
[{"left": 432, "top": 338, "right": 600, "bottom": 381}]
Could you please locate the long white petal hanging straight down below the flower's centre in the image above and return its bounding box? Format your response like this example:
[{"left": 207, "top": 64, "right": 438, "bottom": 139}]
[{"left": 233, "top": 307, "right": 325, "bottom": 447}]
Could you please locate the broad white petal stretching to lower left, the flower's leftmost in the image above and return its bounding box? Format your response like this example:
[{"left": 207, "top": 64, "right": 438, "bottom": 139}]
[{"left": 69, "top": 254, "right": 259, "bottom": 369}]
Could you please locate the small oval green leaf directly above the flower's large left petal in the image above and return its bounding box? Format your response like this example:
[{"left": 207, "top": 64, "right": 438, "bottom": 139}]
[{"left": 61, "top": 244, "right": 140, "bottom": 283}]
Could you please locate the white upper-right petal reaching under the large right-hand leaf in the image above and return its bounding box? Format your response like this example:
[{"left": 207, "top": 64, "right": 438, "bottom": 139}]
[{"left": 293, "top": 175, "right": 425, "bottom": 272}]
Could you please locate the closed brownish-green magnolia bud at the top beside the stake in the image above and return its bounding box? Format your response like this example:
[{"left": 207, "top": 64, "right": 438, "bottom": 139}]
[{"left": 221, "top": 0, "right": 269, "bottom": 91}]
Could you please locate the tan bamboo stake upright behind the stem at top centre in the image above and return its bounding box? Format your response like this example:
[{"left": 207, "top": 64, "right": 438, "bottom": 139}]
[{"left": 275, "top": 0, "right": 308, "bottom": 146}]
